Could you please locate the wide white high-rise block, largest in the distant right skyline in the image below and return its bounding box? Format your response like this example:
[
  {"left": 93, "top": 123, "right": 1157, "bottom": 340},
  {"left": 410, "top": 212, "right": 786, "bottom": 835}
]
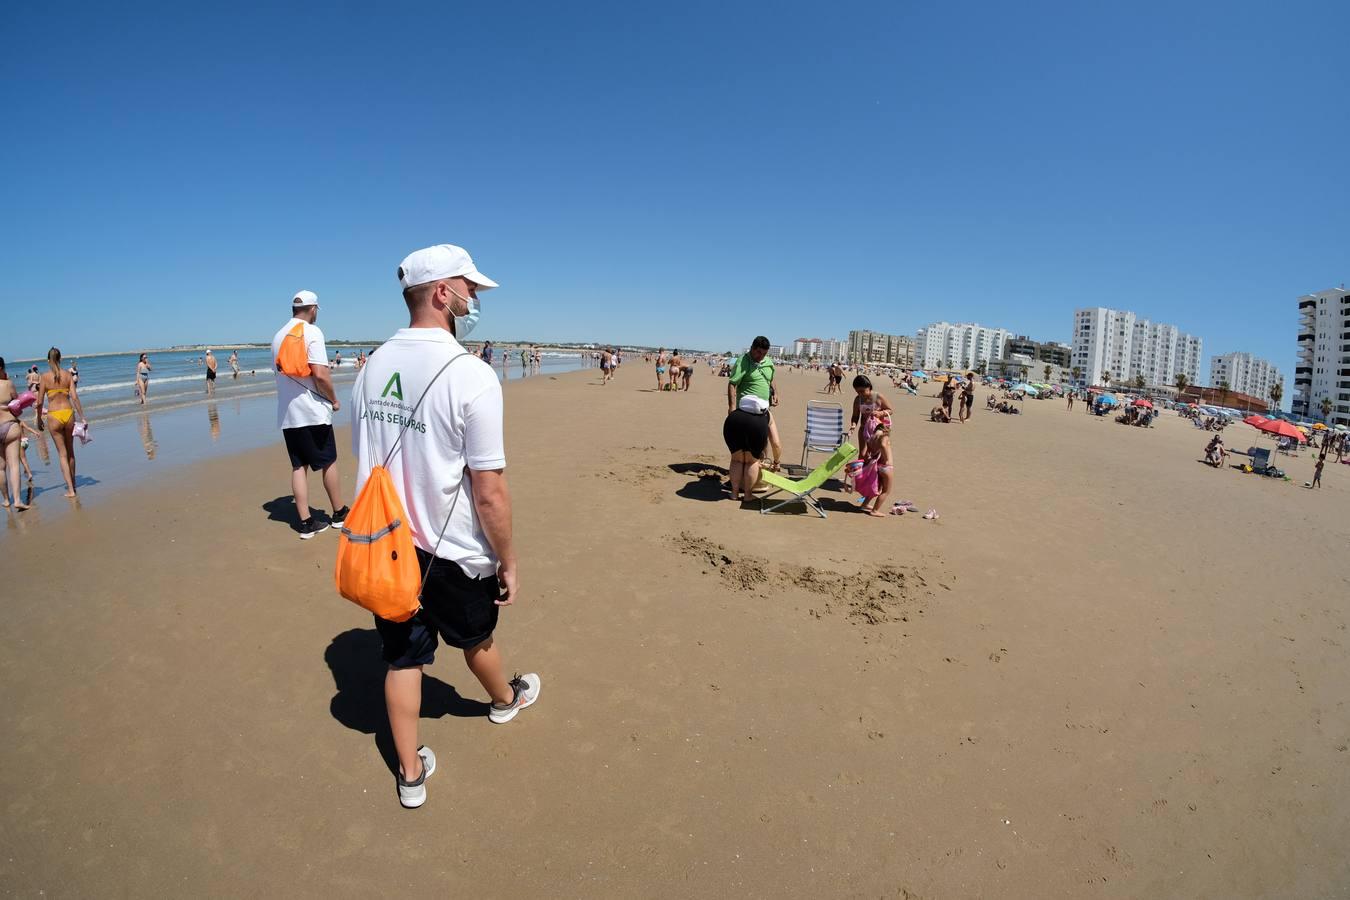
[{"left": 1072, "top": 306, "right": 1204, "bottom": 386}]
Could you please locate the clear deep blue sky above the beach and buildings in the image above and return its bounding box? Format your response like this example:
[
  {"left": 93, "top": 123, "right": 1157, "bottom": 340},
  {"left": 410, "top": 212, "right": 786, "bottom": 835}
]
[{"left": 0, "top": 0, "right": 1350, "bottom": 377}]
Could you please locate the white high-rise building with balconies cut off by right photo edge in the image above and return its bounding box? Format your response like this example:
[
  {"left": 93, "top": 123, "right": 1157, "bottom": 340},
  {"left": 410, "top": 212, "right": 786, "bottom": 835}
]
[{"left": 1293, "top": 286, "right": 1350, "bottom": 425}]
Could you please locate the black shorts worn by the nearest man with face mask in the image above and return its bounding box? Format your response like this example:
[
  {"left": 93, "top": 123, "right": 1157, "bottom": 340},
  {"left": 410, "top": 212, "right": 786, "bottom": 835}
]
[{"left": 375, "top": 546, "right": 501, "bottom": 669}]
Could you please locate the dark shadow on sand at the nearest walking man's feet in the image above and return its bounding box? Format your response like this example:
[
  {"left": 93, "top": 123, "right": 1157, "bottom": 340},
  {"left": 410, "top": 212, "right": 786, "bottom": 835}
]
[{"left": 324, "top": 629, "right": 487, "bottom": 775}]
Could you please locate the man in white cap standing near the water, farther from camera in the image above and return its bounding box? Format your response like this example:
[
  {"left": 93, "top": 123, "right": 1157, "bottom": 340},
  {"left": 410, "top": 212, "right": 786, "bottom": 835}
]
[{"left": 271, "top": 290, "right": 347, "bottom": 541}]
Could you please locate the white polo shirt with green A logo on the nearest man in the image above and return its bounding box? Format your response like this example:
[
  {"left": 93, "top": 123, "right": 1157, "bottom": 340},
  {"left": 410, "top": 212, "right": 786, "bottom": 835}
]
[{"left": 351, "top": 328, "right": 506, "bottom": 578}]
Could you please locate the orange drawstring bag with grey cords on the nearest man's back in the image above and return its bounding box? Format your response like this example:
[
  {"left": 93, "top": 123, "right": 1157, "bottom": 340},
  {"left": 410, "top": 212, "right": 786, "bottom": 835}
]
[{"left": 333, "top": 352, "right": 468, "bottom": 622}]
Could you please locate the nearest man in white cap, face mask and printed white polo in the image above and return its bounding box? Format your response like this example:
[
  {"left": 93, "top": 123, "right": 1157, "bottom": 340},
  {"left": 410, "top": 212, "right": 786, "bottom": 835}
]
[{"left": 351, "top": 244, "right": 540, "bottom": 807}]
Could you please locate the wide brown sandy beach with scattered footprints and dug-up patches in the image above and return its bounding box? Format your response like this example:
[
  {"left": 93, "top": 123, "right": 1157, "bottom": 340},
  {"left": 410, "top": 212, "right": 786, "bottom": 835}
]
[{"left": 0, "top": 358, "right": 1350, "bottom": 899}]
